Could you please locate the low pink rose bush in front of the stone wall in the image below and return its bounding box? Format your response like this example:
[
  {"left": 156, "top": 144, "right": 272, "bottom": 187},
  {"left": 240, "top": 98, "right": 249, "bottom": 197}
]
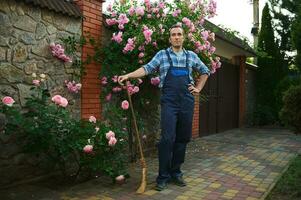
[{"left": 0, "top": 74, "right": 127, "bottom": 181}]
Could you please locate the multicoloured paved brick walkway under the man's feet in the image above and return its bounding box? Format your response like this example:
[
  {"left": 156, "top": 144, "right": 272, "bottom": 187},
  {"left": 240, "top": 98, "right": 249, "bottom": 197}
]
[{"left": 0, "top": 129, "right": 301, "bottom": 200}]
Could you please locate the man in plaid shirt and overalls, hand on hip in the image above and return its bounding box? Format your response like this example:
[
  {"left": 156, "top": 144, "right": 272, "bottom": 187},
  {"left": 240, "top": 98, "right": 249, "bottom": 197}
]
[{"left": 118, "top": 25, "right": 210, "bottom": 191}]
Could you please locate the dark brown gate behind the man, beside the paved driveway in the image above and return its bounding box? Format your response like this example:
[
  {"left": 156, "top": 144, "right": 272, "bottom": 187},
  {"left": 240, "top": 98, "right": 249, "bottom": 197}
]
[{"left": 199, "top": 62, "right": 239, "bottom": 136}]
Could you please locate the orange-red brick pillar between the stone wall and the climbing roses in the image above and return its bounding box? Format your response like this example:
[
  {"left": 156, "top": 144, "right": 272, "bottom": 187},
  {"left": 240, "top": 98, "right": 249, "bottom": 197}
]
[{"left": 74, "top": 0, "right": 103, "bottom": 119}]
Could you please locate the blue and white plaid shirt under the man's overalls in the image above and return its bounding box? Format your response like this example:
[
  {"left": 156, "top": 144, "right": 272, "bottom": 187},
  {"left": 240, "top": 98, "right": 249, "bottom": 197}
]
[{"left": 143, "top": 47, "right": 210, "bottom": 88}]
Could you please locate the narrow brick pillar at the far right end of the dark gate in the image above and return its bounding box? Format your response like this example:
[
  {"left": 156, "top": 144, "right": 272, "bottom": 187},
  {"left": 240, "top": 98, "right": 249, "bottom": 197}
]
[{"left": 232, "top": 56, "right": 246, "bottom": 127}]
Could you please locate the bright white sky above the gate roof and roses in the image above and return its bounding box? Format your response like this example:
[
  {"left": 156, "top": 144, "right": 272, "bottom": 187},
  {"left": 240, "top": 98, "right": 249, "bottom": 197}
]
[{"left": 104, "top": 0, "right": 268, "bottom": 43}]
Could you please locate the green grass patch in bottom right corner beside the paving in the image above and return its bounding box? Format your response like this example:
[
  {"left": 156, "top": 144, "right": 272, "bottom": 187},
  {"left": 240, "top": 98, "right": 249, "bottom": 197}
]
[{"left": 266, "top": 155, "right": 301, "bottom": 200}]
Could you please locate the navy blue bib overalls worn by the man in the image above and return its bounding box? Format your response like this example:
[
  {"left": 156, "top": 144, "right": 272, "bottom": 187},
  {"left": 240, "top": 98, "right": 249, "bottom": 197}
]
[{"left": 157, "top": 50, "right": 194, "bottom": 183}]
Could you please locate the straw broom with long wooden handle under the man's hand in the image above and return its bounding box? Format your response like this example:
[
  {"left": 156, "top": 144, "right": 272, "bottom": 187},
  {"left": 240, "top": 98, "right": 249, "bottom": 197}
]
[{"left": 127, "top": 84, "right": 147, "bottom": 194}]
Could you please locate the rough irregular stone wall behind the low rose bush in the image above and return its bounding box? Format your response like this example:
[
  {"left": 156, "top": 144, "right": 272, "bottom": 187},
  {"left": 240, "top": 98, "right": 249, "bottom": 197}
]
[{"left": 0, "top": 0, "right": 81, "bottom": 186}]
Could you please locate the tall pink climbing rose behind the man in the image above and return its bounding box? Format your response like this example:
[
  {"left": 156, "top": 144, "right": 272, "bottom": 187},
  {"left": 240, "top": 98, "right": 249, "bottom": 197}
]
[{"left": 100, "top": 0, "right": 221, "bottom": 153}]
